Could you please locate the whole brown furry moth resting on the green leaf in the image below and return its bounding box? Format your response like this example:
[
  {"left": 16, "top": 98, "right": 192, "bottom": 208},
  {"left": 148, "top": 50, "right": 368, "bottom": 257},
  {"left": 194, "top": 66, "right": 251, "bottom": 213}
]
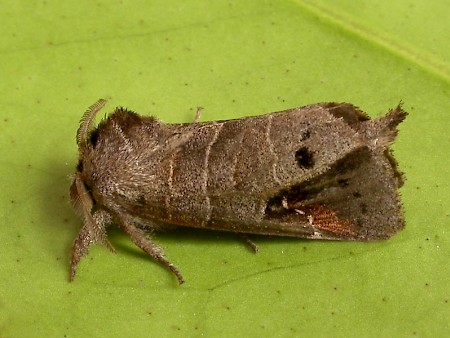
[{"left": 70, "top": 100, "right": 407, "bottom": 284}]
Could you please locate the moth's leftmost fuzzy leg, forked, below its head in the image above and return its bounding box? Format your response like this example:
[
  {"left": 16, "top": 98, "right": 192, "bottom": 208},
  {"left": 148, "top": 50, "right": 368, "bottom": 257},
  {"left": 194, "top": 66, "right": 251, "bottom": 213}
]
[{"left": 70, "top": 210, "right": 115, "bottom": 281}]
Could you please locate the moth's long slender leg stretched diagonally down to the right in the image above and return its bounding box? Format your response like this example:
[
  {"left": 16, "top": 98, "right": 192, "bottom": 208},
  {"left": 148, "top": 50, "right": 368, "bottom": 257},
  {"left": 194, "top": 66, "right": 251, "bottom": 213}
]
[{"left": 119, "top": 217, "right": 184, "bottom": 284}]
